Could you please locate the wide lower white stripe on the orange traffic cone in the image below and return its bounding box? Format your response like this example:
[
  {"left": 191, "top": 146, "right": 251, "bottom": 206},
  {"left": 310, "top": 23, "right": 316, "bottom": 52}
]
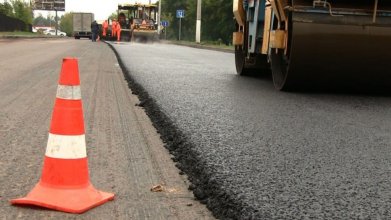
[{"left": 45, "top": 133, "right": 87, "bottom": 159}]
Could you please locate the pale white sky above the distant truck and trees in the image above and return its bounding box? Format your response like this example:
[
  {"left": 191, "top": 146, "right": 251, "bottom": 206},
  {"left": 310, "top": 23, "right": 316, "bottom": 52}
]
[{"left": 0, "top": 0, "right": 156, "bottom": 20}]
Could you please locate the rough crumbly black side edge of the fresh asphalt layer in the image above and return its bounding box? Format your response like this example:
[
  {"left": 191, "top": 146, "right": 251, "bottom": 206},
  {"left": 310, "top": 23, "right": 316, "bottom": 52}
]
[{"left": 105, "top": 42, "right": 257, "bottom": 219}]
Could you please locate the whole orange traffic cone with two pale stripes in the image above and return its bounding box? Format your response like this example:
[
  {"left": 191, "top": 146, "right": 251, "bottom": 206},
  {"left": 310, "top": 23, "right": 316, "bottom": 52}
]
[{"left": 11, "top": 58, "right": 114, "bottom": 213}]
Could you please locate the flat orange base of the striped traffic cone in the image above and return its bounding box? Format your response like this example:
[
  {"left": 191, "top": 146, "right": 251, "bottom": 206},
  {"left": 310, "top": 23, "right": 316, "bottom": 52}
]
[{"left": 11, "top": 183, "right": 114, "bottom": 213}]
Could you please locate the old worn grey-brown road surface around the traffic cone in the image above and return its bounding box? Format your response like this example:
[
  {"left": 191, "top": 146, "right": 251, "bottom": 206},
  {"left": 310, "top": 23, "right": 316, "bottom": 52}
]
[{"left": 0, "top": 38, "right": 214, "bottom": 220}]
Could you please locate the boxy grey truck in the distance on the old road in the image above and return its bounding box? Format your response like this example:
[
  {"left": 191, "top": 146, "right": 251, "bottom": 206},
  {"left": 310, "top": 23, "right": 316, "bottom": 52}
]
[{"left": 72, "top": 13, "right": 94, "bottom": 39}]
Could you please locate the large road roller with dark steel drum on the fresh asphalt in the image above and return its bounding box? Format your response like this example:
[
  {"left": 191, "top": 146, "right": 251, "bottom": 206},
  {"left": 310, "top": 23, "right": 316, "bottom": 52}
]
[{"left": 233, "top": 0, "right": 391, "bottom": 90}]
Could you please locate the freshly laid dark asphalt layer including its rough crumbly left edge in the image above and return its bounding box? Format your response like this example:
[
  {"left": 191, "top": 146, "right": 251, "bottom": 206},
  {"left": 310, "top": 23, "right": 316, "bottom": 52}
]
[{"left": 109, "top": 40, "right": 391, "bottom": 219}]
